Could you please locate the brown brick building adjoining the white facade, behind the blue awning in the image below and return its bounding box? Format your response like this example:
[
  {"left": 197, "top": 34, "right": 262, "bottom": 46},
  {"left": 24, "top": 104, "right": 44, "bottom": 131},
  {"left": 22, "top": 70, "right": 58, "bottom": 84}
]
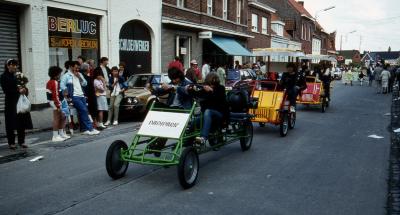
[{"left": 162, "top": 0, "right": 252, "bottom": 72}]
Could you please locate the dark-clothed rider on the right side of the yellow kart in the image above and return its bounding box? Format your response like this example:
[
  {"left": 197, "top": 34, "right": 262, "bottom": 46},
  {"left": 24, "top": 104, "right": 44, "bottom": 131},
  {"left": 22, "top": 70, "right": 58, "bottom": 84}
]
[{"left": 279, "top": 63, "right": 307, "bottom": 113}]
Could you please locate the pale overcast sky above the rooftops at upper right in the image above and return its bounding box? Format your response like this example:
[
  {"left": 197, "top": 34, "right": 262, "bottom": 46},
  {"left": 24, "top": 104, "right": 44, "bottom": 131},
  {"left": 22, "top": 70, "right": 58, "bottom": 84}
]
[{"left": 303, "top": 0, "right": 400, "bottom": 51}]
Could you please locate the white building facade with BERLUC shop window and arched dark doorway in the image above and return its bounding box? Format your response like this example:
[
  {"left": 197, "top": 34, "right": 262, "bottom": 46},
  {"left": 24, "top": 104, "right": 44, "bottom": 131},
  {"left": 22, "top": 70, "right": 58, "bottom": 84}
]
[{"left": 0, "top": 0, "right": 162, "bottom": 107}]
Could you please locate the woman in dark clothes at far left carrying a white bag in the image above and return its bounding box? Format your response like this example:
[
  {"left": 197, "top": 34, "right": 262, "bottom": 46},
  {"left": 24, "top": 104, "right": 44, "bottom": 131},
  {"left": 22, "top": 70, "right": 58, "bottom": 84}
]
[{"left": 0, "top": 59, "right": 33, "bottom": 150}]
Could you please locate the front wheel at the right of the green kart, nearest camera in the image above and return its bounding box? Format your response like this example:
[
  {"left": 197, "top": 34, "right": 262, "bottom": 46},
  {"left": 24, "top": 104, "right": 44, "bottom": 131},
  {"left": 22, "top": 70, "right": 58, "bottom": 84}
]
[{"left": 178, "top": 146, "right": 199, "bottom": 189}]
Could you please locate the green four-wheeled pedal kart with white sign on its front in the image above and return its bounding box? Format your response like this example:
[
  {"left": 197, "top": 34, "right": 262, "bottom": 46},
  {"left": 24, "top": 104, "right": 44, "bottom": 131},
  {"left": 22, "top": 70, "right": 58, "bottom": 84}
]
[{"left": 106, "top": 92, "right": 253, "bottom": 189}]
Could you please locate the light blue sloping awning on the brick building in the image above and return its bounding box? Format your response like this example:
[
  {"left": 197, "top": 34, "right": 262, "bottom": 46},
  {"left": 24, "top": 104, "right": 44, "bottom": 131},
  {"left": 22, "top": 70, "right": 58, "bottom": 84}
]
[{"left": 210, "top": 36, "right": 254, "bottom": 57}]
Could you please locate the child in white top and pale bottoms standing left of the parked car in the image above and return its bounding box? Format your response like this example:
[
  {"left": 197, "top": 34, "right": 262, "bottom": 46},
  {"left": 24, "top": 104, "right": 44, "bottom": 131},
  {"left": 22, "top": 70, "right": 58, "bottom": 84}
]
[{"left": 93, "top": 72, "right": 108, "bottom": 129}]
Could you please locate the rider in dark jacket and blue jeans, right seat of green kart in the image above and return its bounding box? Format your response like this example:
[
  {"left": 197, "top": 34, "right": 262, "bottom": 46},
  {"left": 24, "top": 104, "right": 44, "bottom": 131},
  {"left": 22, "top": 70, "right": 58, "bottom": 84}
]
[{"left": 191, "top": 72, "right": 229, "bottom": 144}]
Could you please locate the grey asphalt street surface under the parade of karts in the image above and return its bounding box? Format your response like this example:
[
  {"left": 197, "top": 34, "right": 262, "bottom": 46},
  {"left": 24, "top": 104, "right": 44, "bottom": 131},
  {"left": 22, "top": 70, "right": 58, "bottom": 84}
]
[{"left": 0, "top": 81, "right": 390, "bottom": 215}]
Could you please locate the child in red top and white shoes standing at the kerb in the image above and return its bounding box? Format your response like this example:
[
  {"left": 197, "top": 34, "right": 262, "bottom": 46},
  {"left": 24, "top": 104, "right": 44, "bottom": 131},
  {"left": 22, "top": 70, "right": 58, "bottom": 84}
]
[{"left": 46, "top": 66, "right": 71, "bottom": 142}]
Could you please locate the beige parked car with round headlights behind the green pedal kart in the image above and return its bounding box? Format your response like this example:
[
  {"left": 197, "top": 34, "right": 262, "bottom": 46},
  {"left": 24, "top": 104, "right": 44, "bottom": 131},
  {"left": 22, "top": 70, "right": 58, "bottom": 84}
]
[{"left": 120, "top": 73, "right": 170, "bottom": 116}]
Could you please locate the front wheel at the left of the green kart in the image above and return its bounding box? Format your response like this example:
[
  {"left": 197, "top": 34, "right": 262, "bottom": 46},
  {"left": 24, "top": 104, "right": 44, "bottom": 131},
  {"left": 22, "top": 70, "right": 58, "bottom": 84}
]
[{"left": 106, "top": 140, "right": 129, "bottom": 179}]
